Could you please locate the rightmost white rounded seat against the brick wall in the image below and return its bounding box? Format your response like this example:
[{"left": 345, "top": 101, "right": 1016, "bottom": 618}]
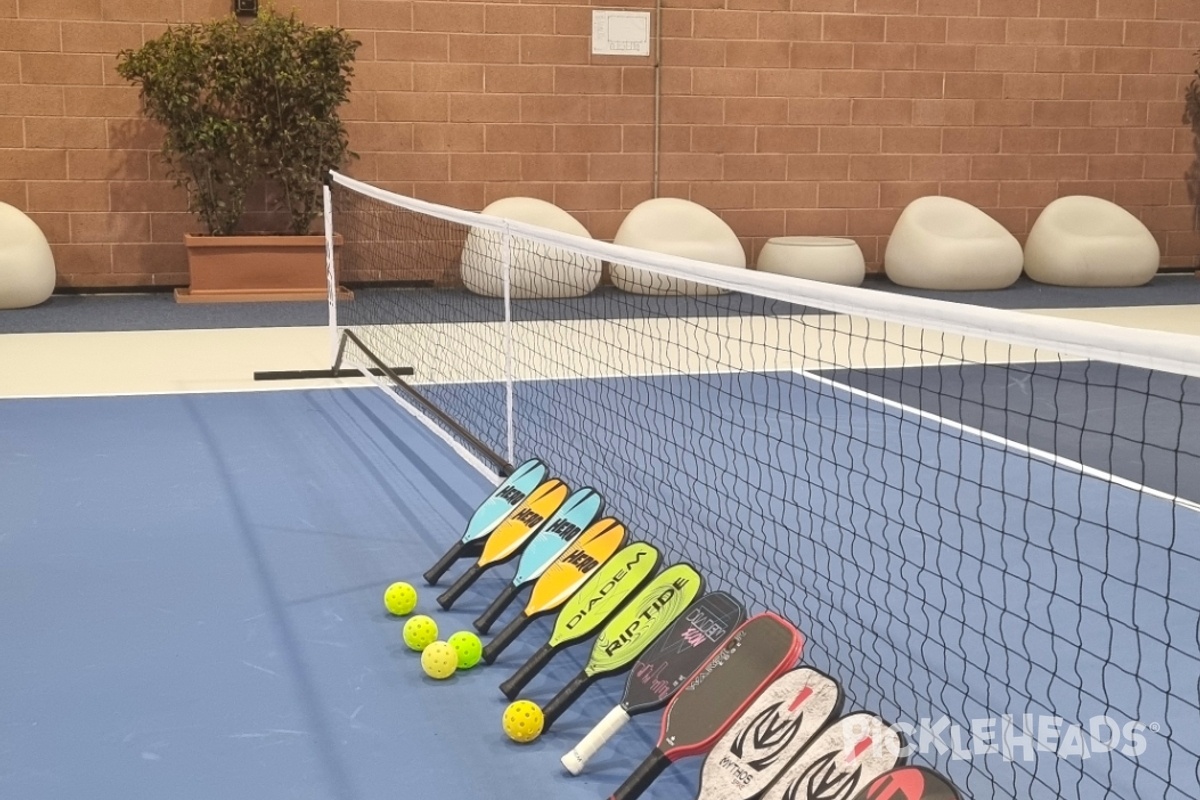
[{"left": 1025, "top": 196, "right": 1162, "bottom": 287}]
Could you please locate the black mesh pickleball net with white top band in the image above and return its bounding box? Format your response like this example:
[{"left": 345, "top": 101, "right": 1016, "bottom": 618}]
[{"left": 329, "top": 175, "right": 1200, "bottom": 800}]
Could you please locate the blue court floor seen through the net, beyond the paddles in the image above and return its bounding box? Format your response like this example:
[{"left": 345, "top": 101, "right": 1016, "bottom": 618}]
[{"left": 415, "top": 362, "right": 1200, "bottom": 800}]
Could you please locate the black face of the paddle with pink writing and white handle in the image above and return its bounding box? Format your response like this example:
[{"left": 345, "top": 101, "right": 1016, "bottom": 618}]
[{"left": 620, "top": 591, "right": 746, "bottom": 716}]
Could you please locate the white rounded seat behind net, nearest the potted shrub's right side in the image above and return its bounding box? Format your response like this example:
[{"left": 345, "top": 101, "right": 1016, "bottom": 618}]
[{"left": 461, "top": 197, "right": 602, "bottom": 299}]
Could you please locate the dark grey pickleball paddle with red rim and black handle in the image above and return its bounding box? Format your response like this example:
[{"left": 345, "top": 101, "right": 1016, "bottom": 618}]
[{"left": 610, "top": 612, "right": 804, "bottom": 800}]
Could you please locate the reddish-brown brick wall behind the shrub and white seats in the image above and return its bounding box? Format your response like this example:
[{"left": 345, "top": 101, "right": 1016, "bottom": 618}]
[{"left": 0, "top": 0, "right": 1200, "bottom": 287}]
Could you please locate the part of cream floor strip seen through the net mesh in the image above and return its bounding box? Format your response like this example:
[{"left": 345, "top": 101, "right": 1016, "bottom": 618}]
[{"left": 343, "top": 314, "right": 1063, "bottom": 384}]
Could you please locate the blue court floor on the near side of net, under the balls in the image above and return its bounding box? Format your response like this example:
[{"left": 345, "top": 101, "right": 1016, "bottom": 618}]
[{"left": 0, "top": 390, "right": 692, "bottom": 800}]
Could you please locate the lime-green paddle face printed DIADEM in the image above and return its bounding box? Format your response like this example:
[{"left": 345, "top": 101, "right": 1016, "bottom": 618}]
[{"left": 550, "top": 542, "right": 660, "bottom": 648}]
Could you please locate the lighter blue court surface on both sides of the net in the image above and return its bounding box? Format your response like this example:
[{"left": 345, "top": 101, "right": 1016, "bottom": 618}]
[{"left": 0, "top": 364, "right": 1200, "bottom": 800}]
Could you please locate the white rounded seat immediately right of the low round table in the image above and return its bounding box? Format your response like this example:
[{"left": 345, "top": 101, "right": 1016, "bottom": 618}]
[{"left": 883, "top": 197, "right": 1024, "bottom": 290}]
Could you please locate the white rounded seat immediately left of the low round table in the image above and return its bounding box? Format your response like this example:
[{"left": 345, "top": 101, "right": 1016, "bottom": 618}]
[{"left": 611, "top": 197, "right": 746, "bottom": 295}]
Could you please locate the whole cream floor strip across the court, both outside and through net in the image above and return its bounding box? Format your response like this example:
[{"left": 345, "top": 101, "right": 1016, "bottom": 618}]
[{"left": 0, "top": 306, "right": 1200, "bottom": 397}]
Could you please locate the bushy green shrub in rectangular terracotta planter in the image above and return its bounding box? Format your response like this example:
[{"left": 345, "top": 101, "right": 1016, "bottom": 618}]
[{"left": 116, "top": 8, "right": 359, "bottom": 301}]
